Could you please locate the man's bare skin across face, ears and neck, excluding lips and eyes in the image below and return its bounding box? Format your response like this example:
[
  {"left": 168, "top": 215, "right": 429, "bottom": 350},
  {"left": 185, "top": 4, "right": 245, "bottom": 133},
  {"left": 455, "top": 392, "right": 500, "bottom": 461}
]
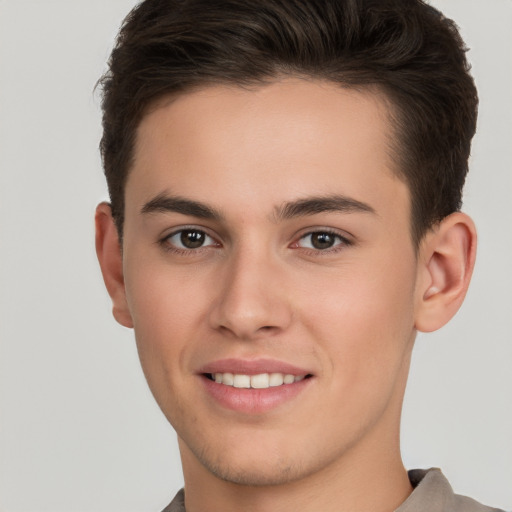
[{"left": 96, "top": 78, "right": 476, "bottom": 512}]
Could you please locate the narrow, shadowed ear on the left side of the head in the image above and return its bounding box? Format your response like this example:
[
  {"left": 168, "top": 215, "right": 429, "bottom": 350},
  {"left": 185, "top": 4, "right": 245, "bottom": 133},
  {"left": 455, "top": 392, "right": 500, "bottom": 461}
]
[{"left": 95, "top": 203, "right": 133, "bottom": 327}]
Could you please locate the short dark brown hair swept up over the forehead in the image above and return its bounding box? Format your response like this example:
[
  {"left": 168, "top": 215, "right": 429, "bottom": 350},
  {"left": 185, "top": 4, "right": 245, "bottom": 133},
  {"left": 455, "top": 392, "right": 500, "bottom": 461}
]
[{"left": 100, "top": 0, "right": 478, "bottom": 244}]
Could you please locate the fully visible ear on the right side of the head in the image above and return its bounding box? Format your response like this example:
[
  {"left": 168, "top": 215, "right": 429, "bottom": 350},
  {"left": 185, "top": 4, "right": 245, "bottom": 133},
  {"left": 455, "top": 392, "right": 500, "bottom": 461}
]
[{"left": 415, "top": 212, "right": 476, "bottom": 332}]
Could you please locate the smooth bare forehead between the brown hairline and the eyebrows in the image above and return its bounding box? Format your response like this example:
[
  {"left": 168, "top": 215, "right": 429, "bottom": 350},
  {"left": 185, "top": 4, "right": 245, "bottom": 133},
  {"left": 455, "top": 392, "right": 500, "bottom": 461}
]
[{"left": 126, "top": 79, "right": 408, "bottom": 224}]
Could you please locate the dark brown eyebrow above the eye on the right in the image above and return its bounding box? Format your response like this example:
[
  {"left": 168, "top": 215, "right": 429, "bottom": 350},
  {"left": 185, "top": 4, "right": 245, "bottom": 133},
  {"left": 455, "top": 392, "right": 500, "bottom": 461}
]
[{"left": 274, "top": 195, "right": 376, "bottom": 220}]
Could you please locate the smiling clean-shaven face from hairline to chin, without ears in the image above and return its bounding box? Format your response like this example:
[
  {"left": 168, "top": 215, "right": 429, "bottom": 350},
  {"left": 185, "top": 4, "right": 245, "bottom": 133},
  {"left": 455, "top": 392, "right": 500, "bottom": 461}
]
[{"left": 123, "top": 79, "right": 417, "bottom": 485}]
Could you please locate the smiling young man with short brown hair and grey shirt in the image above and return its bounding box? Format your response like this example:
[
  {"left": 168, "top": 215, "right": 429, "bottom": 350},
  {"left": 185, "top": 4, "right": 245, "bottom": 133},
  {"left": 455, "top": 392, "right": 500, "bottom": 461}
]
[{"left": 96, "top": 0, "right": 504, "bottom": 512}]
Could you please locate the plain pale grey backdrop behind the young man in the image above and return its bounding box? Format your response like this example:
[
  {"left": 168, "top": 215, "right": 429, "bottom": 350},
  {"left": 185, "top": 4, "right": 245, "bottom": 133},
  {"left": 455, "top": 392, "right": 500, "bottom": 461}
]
[{"left": 0, "top": 0, "right": 512, "bottom": 512}]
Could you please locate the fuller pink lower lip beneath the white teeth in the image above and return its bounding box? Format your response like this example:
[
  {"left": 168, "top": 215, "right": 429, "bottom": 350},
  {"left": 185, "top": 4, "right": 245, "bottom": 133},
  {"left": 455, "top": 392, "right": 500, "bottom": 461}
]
[{"left": 201, "top": 375, "right": 313, "bottom": 414}]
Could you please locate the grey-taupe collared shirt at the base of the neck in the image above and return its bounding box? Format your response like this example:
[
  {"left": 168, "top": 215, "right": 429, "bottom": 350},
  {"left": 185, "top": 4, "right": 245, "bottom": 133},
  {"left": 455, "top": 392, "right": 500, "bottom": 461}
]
[{"left": 162, "top": 468, "right": 503, "bottom": 512}]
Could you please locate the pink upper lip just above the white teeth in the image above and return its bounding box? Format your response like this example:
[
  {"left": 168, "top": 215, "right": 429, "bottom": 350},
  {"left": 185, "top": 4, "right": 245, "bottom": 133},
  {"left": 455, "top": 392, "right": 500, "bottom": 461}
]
[{"left": 198, "top": 359, "right": 311, "bottom": 375}]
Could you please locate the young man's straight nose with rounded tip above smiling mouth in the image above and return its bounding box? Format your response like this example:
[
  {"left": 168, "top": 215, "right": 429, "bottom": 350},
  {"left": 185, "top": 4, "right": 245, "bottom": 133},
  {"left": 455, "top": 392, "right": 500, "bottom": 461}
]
[{"left": 210, "top": 251, "right": 292, "bottom": 340}]
